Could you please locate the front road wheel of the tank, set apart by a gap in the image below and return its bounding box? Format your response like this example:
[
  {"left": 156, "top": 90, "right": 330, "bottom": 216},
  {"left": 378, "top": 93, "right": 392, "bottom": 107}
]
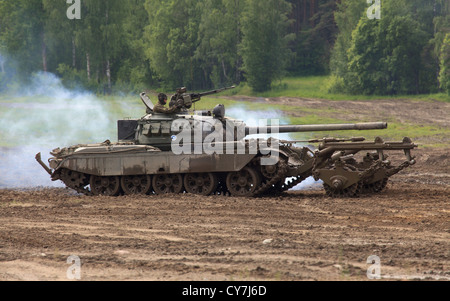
[{"left": 227, "top": 167, "right": 261, "bottom": 196}]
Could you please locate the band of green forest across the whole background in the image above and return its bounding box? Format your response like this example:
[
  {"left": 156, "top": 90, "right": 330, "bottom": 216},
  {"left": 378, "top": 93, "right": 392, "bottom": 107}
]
[{"left": 0, "top": 0, "right": 450, "bottom": 95}]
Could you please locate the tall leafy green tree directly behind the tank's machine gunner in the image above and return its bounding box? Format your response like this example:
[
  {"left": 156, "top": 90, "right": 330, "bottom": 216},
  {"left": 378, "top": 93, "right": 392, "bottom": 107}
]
[{"left": 144, "top": 0, "right": 202, "bottom": 89}]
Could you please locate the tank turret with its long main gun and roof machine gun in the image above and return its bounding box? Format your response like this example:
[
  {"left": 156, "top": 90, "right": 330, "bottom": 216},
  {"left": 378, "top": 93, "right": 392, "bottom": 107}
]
[{"left": 118, "top": 86, "right": 387, "bottom": 151}]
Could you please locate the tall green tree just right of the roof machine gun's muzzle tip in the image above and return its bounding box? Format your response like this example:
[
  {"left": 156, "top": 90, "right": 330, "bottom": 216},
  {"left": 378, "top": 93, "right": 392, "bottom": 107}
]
[{"left": 240, "top": 0, "right": 294, "bottom": 92}]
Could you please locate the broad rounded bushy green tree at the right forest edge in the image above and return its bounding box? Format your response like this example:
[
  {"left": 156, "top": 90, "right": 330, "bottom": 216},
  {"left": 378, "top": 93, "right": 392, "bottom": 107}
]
[{"left": 344, "top": 15, "right": 427, "bottom": 94}]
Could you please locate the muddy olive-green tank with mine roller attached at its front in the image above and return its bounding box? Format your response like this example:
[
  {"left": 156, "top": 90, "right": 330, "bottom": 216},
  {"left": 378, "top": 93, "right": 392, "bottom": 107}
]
[{"left": 36, "top": 87, "right": 417, "bottom": 197}]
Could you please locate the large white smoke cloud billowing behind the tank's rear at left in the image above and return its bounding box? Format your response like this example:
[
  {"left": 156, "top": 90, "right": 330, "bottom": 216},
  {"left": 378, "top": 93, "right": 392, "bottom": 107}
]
[{"left": 0, "top": 72, "right": 139, "bottom": 188}]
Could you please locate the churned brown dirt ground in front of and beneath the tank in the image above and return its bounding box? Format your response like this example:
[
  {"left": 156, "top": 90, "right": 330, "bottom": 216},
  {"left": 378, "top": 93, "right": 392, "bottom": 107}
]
[{"left": 0, "top": 96, "right": 450, "bottom": 281}]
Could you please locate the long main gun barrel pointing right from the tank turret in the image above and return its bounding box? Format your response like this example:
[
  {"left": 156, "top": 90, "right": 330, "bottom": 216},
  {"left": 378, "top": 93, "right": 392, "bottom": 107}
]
[{"left": 245, "top": 122, "right": 387, "bottom": 135}]
